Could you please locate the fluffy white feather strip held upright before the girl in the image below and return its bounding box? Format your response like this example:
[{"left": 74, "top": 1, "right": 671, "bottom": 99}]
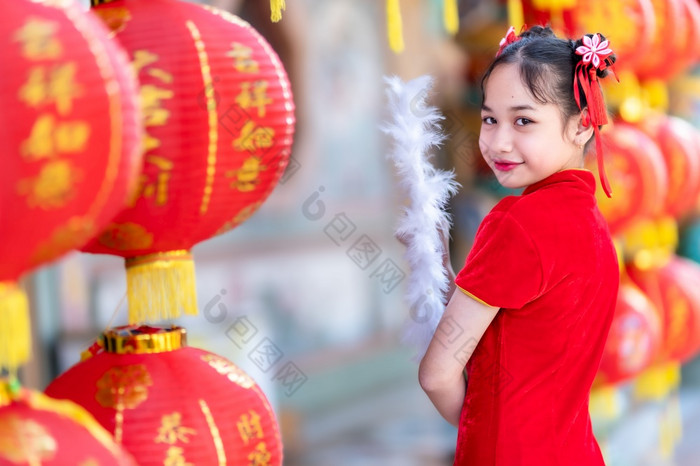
[{"left": 382, "top": 76, "right": 459, "bottom": 358}]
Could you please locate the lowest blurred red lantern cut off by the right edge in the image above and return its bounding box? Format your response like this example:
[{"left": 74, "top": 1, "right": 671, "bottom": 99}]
[{"left": 628, "top": 256, "right": 700, "bottom": 362}]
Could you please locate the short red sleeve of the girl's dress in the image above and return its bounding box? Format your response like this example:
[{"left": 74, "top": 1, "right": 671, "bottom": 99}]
[{"left": 455, "top": 212, "right": 543, "bottom": 309}]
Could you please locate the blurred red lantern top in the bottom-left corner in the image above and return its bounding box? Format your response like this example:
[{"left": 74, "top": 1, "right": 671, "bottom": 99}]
[{"left": 0, "top": 381, "right": 136, "bottom": 466}]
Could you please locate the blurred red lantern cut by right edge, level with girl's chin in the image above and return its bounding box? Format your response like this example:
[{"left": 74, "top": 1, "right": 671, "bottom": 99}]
[{"left": 640, "top": 114, "right": 700, "bottom": 217}]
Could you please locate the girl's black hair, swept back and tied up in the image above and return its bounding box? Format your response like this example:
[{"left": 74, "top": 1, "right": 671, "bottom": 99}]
[{"left": 481, "top": 26, "right": 615, "bottom": 137}]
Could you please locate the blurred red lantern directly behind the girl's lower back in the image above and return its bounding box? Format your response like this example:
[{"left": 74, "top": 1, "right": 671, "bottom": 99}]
[{"left": 596, "top": 275, "right": 661, "bottom": 384}]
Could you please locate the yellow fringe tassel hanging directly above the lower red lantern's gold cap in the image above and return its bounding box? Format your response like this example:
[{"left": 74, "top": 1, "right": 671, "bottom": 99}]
[{"left": 126, "top": 250, "right": 198, "bottom": 324}]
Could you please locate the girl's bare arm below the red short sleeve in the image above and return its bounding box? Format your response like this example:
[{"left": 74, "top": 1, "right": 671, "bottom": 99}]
[{"left": 418, "top": 292, "right": 499, "bottom": 426}]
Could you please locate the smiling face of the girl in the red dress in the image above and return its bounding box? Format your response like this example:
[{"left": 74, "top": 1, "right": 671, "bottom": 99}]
[{"left": 479, "top": 63, "right": 586, "bottom": 189}]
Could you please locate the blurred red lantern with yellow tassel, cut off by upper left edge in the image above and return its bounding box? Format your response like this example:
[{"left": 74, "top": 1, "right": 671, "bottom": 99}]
[{"left": 0, "top": 0, "right": 141, "bottom": 368}]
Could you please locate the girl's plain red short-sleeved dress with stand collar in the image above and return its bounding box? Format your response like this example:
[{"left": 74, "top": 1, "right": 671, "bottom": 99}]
[{"left": 454, "top": 169, "right": 619, "bottom": 466}]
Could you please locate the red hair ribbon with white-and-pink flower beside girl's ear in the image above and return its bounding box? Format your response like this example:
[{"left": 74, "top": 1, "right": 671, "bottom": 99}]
[{"left": 574, "top": 33, "right": 617, "bottom": 197}]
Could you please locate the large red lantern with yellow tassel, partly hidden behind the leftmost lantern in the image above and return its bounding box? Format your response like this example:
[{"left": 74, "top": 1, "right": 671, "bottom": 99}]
[{"left": 84, "top": 0, "right": 294, "bottom": 323}]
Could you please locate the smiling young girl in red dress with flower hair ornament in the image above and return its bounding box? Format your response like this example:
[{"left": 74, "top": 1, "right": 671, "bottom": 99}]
[{"left": 419, "top": 27, "right": 619, "bottom": 466}]
